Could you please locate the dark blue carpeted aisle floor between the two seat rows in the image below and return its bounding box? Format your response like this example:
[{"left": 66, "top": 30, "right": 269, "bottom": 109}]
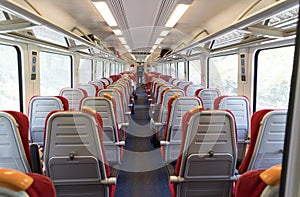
[{"left": 115, "top": 87, "right": 171, "bottom": 197}]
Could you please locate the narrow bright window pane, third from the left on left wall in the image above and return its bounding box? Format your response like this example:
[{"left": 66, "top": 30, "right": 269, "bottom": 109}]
[{"left": 78, "top": 58, "right": 93, "bottom": 83}]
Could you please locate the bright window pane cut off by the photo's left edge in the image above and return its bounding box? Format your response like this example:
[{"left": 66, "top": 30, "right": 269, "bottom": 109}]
[{"left": 0, "top": 45, "right": 20, "bottom": 111}]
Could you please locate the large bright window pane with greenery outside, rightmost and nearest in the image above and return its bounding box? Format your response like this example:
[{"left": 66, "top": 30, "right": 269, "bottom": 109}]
[{"left": 256, "top": 46, "right": 295, "bottom": 110}]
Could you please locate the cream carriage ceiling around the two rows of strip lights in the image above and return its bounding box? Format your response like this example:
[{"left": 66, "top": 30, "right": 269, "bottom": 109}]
[{"left": 2, "top": 0, "right": 290, "bottom": 59}]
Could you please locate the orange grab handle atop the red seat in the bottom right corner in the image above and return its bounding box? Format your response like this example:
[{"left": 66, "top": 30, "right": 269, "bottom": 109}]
[{"left": 259, "top": 164, "right": 282, "bottom": 186}]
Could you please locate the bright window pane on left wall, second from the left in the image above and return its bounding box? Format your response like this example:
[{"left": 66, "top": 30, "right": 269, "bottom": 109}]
[{"left": 40, "top": 52, "right": 72, "bottom": 96}]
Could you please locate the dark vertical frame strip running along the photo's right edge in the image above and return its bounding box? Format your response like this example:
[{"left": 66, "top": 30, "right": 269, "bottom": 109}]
[{"left": 279, "top": 13, "right": 300, "bottom": 196}]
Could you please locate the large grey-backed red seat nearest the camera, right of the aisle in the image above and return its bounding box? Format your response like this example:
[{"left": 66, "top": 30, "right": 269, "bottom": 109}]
[{"left": 169, "top": 107, "right": 237, "bottom": 197}]
